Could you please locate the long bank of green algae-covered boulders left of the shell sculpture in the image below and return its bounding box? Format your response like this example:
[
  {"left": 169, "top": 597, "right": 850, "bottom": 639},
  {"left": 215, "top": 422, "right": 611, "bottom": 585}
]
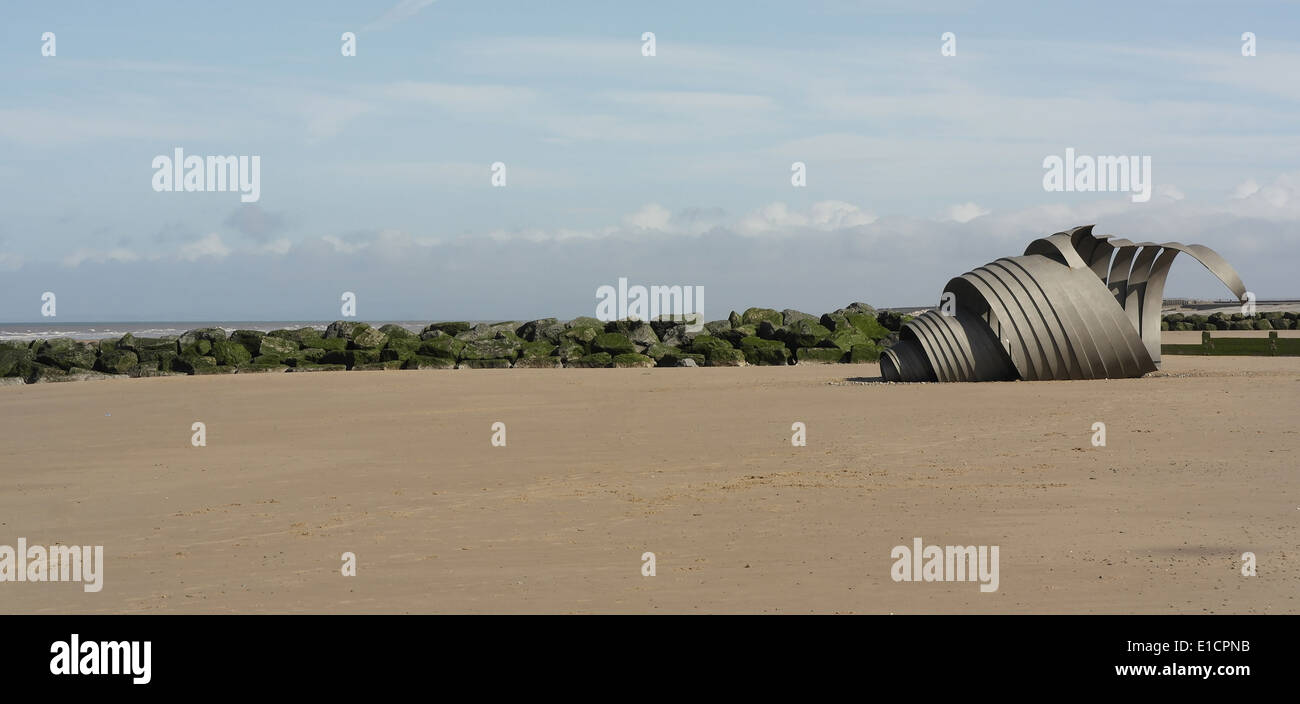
[{"left": 0, "top": 303, "right": 910, "bottom": 383}]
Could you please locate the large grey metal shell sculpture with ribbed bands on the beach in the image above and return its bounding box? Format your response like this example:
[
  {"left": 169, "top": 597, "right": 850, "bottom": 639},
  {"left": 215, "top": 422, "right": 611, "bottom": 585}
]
[{"left": 880, "top": 225, "right": 1245, "bottom": 382}]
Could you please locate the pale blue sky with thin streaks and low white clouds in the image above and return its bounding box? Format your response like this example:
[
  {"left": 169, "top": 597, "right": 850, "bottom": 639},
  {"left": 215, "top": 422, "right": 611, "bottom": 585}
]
[{"left": 0, "top": 0, "right": 1300, "bottom": 322}]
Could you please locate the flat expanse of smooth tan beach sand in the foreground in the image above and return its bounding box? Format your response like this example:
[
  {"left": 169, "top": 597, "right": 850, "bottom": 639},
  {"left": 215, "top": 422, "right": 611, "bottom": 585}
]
[{"left": 0, "top": 357, "right": 1300, "bottom": 613}]
